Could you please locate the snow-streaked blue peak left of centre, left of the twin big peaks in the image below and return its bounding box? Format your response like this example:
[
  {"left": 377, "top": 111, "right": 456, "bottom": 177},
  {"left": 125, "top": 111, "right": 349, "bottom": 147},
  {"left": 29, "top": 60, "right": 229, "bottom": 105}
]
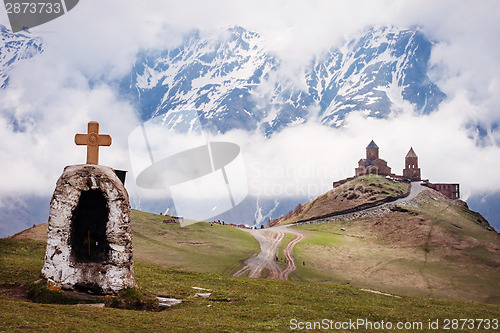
[{"left": 119, "top": 27, "right": 278, "bottom": 132}]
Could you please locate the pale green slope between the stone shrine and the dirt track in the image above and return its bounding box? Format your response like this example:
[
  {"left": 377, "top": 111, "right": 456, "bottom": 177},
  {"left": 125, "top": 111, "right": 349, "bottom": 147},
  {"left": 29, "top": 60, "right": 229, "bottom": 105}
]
[{"left": 131, "top": 210, "right": 260, "bottom": 274}]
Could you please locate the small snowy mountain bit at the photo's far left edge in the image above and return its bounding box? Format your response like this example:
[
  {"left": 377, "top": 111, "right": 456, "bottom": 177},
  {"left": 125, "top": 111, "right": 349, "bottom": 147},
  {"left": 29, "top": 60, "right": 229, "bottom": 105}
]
[{"left": 0, "top": 25, "right": 43, "bottom": 88}]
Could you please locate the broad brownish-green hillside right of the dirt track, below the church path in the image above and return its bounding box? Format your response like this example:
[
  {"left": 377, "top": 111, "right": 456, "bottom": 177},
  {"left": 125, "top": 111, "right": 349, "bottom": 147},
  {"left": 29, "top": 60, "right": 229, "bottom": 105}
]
[{"left": 294, "top": 190, "right": 500, "bottom": 304}]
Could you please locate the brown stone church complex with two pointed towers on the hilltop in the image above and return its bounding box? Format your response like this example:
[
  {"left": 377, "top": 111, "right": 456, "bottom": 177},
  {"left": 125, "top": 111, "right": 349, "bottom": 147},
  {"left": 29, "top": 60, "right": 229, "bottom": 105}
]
[{"left": 350, "top": 140, "right": 460, "bottom": 199}]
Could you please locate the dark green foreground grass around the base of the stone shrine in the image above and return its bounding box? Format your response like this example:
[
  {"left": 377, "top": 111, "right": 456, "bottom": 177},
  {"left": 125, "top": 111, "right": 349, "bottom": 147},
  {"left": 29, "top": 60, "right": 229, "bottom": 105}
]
[{"left": 0, "top": 239, "right": 500, "bottom": 332}]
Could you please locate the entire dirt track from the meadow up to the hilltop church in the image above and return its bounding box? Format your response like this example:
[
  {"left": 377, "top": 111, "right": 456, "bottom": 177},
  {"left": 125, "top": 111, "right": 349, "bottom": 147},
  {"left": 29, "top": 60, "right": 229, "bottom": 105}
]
[{"left": 233, "top": 181, "right": 426, "bottom": 280}]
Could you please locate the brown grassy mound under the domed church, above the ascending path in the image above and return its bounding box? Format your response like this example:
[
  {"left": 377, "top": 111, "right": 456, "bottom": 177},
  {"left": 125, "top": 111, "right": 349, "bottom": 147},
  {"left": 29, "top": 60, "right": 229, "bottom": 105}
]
[{"left": 270, "top": 175, "right": 409, "bottom": 225}]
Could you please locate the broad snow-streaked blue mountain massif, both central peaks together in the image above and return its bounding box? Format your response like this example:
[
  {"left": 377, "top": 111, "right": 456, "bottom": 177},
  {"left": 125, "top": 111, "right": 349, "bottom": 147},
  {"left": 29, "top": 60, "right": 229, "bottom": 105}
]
[{"left": 122, "top": 27, "right": 445, "bottom": 135}]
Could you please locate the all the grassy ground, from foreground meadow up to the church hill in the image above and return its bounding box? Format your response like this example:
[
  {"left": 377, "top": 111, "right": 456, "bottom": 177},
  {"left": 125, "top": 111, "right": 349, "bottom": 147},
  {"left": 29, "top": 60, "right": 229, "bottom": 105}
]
[{"left": 0, "top": 182, "right": 500, "bottom": 332}]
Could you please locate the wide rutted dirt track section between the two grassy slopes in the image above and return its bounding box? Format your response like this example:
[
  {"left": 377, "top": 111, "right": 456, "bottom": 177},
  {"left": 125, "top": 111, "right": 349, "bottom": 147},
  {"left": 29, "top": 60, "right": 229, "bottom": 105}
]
[{"left": 233, "top": 227, "right": 304, "bottom": 280}]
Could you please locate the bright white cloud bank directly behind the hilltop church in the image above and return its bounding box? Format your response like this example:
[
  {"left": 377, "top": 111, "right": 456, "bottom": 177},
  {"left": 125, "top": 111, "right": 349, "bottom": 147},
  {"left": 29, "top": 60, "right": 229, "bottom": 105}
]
[{"left": 214, "top": 92, "right": 500, "bottom": 202}]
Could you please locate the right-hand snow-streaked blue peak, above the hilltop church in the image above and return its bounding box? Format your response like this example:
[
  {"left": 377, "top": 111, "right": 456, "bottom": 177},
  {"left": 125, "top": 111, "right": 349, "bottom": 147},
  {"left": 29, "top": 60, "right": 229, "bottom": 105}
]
[{"left": 306, "top": 27, "right": 445, "bottom": 126}]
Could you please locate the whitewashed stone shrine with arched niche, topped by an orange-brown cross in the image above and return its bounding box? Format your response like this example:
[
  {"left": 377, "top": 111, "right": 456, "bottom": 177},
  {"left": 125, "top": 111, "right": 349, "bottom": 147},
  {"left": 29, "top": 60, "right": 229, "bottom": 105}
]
[{"left": 42, "top": 121, "right": 135, "bottom": 294}]
